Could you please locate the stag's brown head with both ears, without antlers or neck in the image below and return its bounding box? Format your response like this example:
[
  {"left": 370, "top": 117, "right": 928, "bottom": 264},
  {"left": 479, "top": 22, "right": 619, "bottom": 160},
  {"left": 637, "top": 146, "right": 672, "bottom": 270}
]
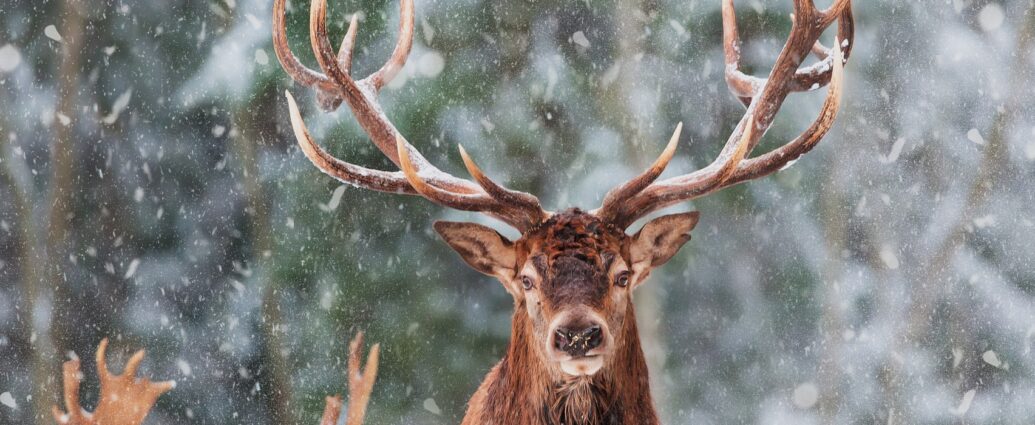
[{"left": 436, "top": 209, "right": 698, "bottom": 375}]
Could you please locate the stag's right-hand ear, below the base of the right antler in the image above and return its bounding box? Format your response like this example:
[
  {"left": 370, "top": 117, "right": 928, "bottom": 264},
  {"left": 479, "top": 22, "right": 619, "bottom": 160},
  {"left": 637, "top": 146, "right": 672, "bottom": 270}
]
[{"left": 629, "top": 211, "right": 701, "bottom": 270}]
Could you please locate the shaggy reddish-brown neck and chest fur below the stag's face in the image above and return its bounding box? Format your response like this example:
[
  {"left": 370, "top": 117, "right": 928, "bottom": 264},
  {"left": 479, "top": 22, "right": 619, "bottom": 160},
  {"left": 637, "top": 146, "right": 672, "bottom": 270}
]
[{"left": 464, "top": 299, "right": 658, "bottom": 425}]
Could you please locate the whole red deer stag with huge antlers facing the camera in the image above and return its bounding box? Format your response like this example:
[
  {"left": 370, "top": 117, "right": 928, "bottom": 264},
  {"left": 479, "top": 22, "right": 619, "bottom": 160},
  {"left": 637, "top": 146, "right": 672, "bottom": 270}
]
[{"left": 273, "top": 0, "right": 853, "bottom": 425}]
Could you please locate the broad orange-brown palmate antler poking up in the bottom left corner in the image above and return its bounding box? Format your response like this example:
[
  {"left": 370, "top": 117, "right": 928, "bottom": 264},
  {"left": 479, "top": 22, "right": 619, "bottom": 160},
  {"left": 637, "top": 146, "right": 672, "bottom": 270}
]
[{"left": 53, "top": 338, "right": 176, "bottom": 425}]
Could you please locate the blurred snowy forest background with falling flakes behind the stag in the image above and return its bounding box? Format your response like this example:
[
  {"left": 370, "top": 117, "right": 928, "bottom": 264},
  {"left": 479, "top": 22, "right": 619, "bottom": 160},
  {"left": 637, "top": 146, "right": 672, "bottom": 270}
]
[{"left": 0, "top": 0, "right": 1035, "bottom": 424}]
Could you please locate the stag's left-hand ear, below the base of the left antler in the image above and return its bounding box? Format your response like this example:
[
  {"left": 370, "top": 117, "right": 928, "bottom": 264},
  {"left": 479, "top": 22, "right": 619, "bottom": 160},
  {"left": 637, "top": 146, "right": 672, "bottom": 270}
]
[{"left": 435, "top": 221, "right": 516, "bottom": 278}]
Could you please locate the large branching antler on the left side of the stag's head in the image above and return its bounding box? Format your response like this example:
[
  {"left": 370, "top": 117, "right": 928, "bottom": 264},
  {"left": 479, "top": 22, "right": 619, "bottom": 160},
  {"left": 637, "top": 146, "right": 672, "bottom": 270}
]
[{"left": 273, "top": 0, "right": 550, "bottom": 231}]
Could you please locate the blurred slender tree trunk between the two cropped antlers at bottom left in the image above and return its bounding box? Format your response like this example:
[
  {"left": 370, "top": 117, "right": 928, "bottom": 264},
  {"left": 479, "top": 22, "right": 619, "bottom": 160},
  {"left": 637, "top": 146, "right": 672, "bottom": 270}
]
[{"left": 231, "top": 105, "right": 299, "bottom": 424}]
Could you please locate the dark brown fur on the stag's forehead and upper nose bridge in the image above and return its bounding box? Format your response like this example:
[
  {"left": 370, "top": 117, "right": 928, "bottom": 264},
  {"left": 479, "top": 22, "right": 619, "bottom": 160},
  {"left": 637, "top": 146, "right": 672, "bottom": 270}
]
[{"left": 523, "top": 209, "right": 625, "bottom": 304}]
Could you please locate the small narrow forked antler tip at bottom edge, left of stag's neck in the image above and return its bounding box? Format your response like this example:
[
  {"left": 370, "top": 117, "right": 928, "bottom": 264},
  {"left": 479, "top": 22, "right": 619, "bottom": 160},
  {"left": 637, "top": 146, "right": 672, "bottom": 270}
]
[{"left": 320, "top": 332, "right": 381, "bottom": 425}]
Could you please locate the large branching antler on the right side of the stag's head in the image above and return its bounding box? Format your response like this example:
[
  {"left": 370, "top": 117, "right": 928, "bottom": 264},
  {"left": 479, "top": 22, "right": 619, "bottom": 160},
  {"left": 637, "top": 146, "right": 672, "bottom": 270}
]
[{"left": 594, "top": 0, "right": 854, "bottom": 229}]
